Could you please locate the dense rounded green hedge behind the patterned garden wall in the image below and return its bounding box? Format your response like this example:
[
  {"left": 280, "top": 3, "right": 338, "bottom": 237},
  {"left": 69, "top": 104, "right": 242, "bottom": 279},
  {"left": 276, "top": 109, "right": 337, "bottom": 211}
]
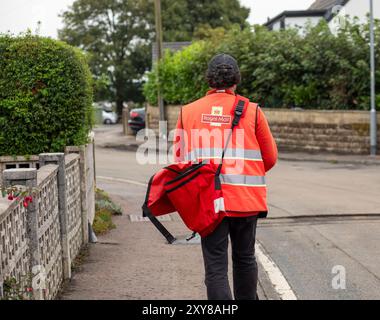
[{"left": 0, "top": 34, "right": 93, "bottom": 155}]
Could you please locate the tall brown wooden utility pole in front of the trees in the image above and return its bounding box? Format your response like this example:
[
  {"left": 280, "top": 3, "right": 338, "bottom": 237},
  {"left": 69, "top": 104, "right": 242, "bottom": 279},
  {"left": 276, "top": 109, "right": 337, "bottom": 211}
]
[{"left": 154, "top": 0, "right": 166, "bottom": 138}]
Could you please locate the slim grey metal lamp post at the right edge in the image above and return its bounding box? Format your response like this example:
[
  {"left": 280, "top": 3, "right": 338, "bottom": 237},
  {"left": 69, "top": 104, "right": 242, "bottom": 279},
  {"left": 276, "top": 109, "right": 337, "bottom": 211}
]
[{"left": 369, "top": 0, "right": 377, "bottom": 156}]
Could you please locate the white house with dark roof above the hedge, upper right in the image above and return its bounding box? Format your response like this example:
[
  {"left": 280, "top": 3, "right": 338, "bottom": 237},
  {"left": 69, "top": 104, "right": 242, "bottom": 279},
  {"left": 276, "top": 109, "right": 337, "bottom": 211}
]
[{"left": 264, "top": 0, "right": 380, "bottom": 30}]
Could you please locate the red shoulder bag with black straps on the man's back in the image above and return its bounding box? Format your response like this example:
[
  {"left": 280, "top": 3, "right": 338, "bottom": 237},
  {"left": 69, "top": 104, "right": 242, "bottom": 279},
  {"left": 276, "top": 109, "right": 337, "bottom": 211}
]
[{"left": 142, "top": 96, "right": 249, "bottom": 243}]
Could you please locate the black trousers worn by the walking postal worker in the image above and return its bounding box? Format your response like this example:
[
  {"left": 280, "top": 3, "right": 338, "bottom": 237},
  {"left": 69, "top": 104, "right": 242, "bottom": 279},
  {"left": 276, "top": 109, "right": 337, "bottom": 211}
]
[{"left": 202, "top": 216, "right": 258, "bottom": 300}]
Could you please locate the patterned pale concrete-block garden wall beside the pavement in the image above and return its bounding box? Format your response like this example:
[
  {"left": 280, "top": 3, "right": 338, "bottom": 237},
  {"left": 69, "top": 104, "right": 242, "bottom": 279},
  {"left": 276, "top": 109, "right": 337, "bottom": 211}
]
[{"left": 0, "top": 139, "right": 95, "bottom": 299}]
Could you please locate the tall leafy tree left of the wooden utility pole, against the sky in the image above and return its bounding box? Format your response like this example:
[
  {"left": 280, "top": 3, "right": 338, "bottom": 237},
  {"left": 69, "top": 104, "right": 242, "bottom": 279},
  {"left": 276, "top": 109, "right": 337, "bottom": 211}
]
[{"left": 58, "top": 0, "right": 152, "bottom": 113}]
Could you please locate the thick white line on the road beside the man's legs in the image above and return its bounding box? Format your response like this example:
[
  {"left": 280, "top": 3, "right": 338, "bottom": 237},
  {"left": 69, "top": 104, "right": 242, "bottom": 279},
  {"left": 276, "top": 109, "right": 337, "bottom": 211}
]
[{"left": 256, "top": 243, "right": 297, "bottom": 300}]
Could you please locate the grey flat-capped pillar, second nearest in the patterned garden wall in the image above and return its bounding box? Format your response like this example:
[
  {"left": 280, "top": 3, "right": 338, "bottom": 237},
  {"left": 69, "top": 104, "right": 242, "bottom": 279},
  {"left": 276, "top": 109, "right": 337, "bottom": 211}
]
[{"left": 39, "top": 153, "right": 71, "bottom": 280}]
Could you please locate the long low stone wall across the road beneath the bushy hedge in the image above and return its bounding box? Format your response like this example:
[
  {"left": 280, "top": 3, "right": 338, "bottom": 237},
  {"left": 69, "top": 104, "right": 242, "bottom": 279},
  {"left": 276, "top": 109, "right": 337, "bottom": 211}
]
[{"left": 147, "top": 106, "right": 380, "bottom": 154}]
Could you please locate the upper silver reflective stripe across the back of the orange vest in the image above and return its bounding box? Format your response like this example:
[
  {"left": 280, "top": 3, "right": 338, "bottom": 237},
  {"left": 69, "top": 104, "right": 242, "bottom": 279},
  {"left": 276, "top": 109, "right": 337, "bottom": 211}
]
[{"left": 186, "top": 148, "right": 263, "bottom": 161}]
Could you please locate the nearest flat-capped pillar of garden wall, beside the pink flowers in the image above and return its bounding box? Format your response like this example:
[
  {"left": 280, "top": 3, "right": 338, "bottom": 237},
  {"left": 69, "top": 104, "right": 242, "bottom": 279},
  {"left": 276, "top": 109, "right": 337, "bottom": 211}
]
[{"left": 3, "top": 168, "right": 44, "bottom": 300}]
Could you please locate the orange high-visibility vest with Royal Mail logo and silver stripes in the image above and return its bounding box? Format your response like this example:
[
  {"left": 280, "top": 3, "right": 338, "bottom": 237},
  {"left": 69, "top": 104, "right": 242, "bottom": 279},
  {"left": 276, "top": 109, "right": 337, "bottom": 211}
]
[{"left": 175, "top": 90, "right": 277, "bottom": 217}]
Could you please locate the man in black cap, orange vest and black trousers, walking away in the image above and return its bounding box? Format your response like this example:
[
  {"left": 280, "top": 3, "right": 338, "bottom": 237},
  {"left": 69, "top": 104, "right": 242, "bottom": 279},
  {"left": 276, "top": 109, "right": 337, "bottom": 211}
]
[{"left": 177, "top": 54, "right": 277, "bottom": 300}]
